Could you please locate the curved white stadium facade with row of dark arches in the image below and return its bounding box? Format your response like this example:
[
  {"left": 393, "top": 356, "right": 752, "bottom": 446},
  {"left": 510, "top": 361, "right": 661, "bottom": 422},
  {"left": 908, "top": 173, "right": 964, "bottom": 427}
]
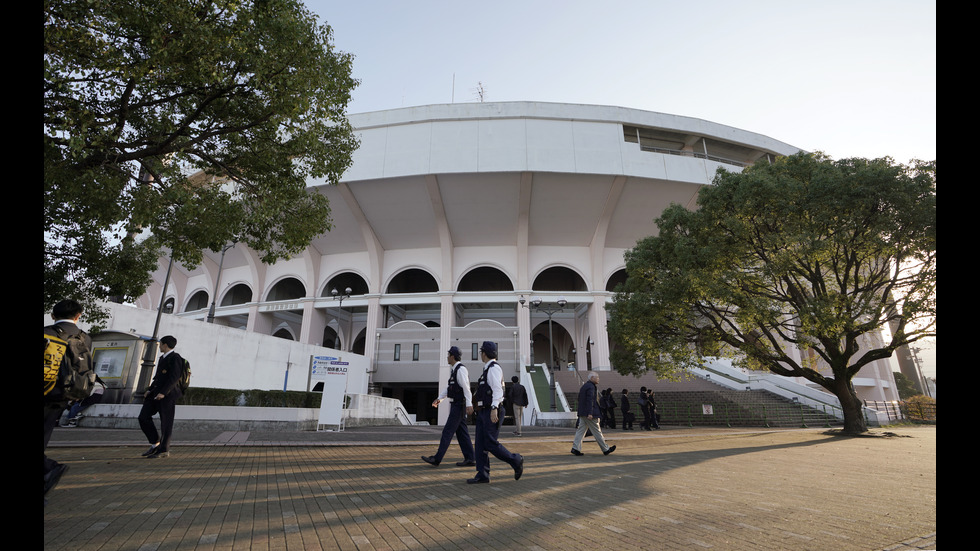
[{"left": 138, "top": 102, "right": 798, "bottom": 404}]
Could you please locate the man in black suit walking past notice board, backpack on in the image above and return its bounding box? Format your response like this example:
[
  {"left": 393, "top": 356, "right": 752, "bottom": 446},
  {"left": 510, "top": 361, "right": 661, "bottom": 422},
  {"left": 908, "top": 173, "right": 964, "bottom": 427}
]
[{"left": 139, "top": 335, "right": 184, "bottom": 459}]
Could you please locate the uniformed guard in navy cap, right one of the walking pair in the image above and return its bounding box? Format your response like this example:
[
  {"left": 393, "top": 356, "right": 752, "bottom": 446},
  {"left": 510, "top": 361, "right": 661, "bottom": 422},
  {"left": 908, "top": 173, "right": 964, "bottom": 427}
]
[{"left": 466, "top": 341, "right": 524, "bottom": 484}]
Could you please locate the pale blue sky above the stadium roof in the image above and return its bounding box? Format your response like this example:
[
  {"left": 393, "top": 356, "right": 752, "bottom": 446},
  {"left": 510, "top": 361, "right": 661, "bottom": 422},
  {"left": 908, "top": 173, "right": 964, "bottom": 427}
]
[{"left": 306, "top": 0, "right": 936, "bottom": 163}]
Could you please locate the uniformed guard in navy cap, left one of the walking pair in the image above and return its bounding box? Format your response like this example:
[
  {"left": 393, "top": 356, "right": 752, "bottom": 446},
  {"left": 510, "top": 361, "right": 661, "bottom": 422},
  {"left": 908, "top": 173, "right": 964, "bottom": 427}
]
[{"left": 422, "top": 346, "right": 476, "bottom": 467}]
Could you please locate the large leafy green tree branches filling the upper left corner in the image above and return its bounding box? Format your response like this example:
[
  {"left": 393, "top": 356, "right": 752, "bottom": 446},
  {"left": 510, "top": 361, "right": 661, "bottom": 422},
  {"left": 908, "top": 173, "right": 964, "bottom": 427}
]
[{"left": 43, "top": 0, "right": 358, "bottom": 324}]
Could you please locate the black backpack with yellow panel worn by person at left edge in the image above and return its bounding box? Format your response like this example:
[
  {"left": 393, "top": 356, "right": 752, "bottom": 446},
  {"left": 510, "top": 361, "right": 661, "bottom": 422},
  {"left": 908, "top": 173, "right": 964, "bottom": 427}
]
[{"left": 44, "top": 324, "right": 95, "bottom": 400}]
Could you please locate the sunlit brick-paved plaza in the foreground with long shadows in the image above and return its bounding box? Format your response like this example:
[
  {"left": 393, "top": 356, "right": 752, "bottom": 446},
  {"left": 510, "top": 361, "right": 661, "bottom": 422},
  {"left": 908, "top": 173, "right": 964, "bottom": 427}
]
[{"left": 44, "top": 427, "right": 936, "bottom": 551}]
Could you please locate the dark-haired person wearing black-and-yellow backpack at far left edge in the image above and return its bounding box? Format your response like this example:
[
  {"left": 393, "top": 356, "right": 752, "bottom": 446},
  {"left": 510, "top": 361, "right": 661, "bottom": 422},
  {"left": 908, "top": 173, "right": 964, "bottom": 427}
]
[{"left": 44, "top": 299, "right": 95, "bottom": 503}]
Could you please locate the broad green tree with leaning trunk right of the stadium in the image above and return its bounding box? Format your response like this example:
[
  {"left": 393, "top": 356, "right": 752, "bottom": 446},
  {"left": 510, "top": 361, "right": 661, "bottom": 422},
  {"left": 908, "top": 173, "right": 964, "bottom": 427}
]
[{"left": 608, "top": 153, "right": 936, "bottom": 434}]
